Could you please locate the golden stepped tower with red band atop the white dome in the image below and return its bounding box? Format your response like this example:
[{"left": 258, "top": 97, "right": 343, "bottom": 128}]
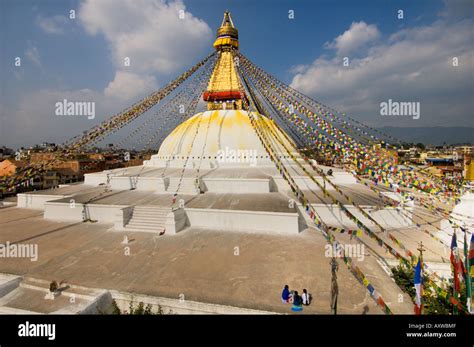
[{"left": 203, "top": 11, "right": 243, "bottom": 110}]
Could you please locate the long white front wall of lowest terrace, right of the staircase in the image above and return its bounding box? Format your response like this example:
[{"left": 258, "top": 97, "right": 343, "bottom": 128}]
[{"left": 185, "top": 208, "right": 299, "bottom": 235}]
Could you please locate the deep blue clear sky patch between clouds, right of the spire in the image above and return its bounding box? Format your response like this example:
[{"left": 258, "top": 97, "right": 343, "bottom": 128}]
[{"left": 186, "top": 0, "right": 443, "bottom": 79}]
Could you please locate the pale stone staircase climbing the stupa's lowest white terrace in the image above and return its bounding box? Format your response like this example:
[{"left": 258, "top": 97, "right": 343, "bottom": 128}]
[{"left": 125, "top": 206, "right": 171, "bottom": 233}]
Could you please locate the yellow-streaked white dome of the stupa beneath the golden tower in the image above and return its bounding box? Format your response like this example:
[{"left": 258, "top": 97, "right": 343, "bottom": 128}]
[{"left": 144, "top": 110, "right": 294, "bottom": 168}]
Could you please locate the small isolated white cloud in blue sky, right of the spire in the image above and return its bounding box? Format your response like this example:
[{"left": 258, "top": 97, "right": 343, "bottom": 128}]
[{"left": 326, "top": 21, "right": 380, "bottom": 56}]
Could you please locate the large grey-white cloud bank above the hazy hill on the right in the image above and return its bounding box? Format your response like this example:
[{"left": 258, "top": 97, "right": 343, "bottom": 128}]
[{"left": 291, "top": 20, "right": 474, "bottom": 126}]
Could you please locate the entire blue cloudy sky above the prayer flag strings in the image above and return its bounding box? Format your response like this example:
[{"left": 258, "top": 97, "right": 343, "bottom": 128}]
[{"left": 0, "top": 0, "right": 474, "bottom": 146}]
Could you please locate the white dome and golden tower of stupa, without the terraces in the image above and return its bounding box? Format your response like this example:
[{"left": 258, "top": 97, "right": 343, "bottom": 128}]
[{"left": 144, "top": 11, "right": 294, "bottom": 168}]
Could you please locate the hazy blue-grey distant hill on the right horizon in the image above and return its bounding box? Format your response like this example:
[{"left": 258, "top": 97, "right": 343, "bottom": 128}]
[{"left": 378, "top": 127, "right": 474, "bottom": 145}]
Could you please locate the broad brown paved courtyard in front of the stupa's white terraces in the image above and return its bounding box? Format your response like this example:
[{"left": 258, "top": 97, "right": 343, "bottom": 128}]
[{"left": 0, "top": 207, "right": 396, "bottom": 314}]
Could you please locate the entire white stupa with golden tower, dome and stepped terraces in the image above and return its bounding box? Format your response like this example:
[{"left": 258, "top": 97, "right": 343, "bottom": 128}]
[{"left": 18, "top": 11, "right": 412, "bottom": 239}]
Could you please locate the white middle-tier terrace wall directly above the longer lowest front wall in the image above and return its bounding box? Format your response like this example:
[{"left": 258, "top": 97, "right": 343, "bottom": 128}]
[{"left": 201, "top": 178, "right": 270, "bottom": 194}]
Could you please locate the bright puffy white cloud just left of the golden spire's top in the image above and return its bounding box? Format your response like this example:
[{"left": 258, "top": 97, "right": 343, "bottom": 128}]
[{"left": 79, "top": 0, "right": 212, "bottom": 74}]
